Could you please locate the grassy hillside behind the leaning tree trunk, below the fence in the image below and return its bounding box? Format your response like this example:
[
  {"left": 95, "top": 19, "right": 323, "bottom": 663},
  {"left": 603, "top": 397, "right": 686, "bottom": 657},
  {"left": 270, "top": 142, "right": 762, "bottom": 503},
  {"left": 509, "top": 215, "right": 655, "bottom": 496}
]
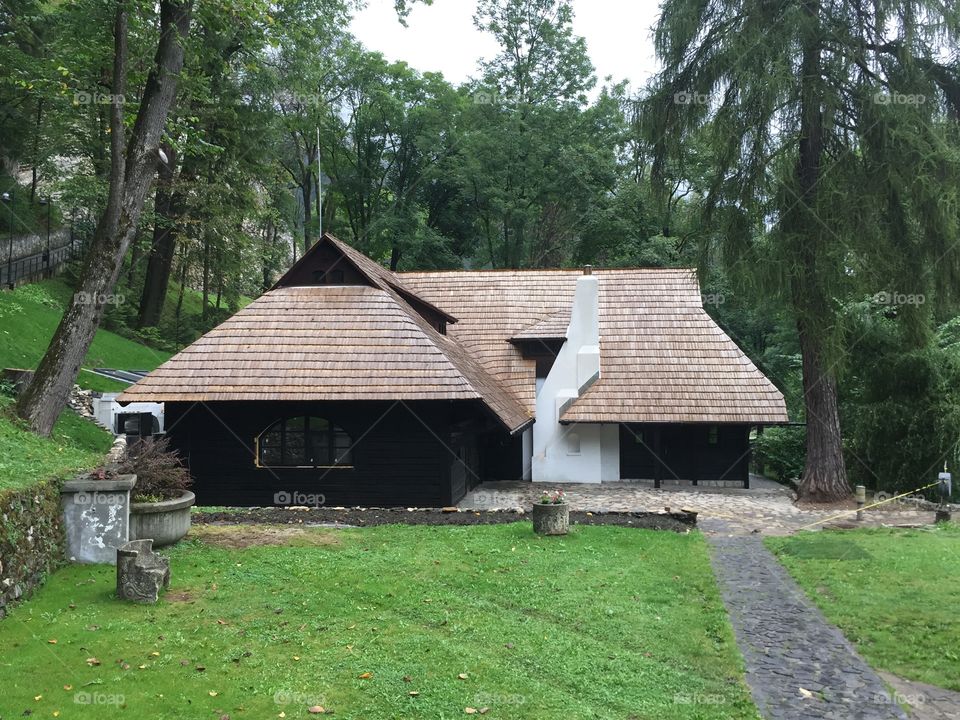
[{"left": 0, "top": 279, "right": 169, "bottom": 391}]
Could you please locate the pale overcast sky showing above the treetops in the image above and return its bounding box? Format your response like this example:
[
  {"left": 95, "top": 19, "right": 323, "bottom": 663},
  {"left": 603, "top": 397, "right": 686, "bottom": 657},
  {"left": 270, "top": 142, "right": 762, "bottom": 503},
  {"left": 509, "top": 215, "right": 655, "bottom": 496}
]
[{"left": 350, "top": 0, "right": 659, "bottom": 88}]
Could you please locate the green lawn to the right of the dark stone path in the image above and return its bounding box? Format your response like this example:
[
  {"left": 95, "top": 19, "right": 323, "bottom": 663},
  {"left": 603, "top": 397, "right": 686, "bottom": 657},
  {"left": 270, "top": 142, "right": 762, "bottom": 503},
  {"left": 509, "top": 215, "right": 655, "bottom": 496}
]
[{"left": 766, "top": 524, "right": 960, "bottom": 690}]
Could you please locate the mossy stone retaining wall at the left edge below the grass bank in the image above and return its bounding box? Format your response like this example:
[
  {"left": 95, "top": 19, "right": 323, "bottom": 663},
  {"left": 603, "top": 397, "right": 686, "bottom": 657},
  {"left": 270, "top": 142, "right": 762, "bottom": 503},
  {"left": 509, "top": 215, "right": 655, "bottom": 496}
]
[{"left": 0, "top": 480, "right": 66, "bottom": 618}]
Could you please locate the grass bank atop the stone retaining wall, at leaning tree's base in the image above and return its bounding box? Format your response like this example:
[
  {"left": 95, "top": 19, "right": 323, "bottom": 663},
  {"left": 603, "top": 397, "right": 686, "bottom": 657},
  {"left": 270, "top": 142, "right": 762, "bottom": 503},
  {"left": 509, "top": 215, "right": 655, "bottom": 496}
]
[{"left": 0, "top": 397, "right": 113, "bottom": 490}]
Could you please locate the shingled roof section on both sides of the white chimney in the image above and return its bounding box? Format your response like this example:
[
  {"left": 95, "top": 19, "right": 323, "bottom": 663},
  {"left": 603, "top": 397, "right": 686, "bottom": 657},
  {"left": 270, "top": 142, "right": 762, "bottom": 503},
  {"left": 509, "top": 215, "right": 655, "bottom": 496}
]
[{"left": 400, "top": 269, "right": 787, "bottom": 424}]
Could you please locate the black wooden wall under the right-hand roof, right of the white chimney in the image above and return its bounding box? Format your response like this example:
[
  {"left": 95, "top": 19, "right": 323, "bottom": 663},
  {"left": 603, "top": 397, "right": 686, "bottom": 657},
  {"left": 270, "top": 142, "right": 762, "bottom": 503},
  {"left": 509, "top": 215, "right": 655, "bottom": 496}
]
[{"left": 620, "top": 423, "right": 750, "bottom": 485}]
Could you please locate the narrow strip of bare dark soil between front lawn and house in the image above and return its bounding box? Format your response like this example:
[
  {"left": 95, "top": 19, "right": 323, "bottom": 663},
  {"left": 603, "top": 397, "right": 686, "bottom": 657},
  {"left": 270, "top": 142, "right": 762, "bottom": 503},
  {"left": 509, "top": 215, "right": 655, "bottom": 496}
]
[{"left": 193, "top": 508, "right": 697, "bottom": 544}]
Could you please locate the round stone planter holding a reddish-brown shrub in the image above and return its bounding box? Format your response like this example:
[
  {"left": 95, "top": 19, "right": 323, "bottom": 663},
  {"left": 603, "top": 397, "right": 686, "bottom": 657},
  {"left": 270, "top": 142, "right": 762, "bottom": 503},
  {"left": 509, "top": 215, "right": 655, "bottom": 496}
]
[{"left": 117, "top": 438, "right": 196, "bottom": 547}]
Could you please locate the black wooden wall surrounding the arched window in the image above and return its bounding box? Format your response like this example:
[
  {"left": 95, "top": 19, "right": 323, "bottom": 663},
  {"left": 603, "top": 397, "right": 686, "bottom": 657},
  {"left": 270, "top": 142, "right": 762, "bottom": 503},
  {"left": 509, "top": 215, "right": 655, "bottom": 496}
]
[{"left": 165, "top": 401, "right": 496, "bottom": 507}]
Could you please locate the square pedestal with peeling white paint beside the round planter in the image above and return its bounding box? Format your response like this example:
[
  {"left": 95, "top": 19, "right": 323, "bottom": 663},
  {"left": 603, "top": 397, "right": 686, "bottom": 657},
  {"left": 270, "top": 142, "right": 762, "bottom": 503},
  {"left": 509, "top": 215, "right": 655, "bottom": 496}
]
[{"left": 60, "top": 475, "right": 137, "bottom": 565}]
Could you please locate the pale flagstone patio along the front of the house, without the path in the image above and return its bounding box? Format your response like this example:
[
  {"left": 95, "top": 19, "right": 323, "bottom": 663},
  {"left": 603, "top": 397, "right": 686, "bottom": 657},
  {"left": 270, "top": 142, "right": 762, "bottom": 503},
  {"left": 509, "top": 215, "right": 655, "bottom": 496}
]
[{"left": 460, "top": 476, "right": 933, "bottom": 535}]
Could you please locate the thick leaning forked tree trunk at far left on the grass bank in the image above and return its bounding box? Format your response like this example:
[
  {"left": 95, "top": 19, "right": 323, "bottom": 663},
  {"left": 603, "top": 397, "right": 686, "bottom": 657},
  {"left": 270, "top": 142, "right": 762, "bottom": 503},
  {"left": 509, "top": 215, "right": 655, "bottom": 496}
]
[{"left": 17, "top": 0, "right": 191, "bottom": 435}]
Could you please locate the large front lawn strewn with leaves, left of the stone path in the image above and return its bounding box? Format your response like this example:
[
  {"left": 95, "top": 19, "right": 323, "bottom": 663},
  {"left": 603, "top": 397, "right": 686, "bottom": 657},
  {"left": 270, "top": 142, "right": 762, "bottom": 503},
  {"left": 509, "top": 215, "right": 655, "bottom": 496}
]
[{"left": 0, "top": 523, "right": 757, "bottom": 720}]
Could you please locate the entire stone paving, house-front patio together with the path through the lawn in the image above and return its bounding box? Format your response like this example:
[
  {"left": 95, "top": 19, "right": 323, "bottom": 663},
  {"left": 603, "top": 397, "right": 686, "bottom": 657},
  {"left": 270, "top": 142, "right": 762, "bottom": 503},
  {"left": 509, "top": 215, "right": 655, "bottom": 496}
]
[{"left": 460, "top": 476, "right": 948, "bottom": 720}]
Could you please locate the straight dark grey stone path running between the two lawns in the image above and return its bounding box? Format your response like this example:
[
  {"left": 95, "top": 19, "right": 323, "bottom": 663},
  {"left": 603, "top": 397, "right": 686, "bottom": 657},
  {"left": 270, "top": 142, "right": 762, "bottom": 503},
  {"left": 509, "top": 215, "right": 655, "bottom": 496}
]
[{"left": 707, "top": 535, "right": 907, "bottom": 720}]
